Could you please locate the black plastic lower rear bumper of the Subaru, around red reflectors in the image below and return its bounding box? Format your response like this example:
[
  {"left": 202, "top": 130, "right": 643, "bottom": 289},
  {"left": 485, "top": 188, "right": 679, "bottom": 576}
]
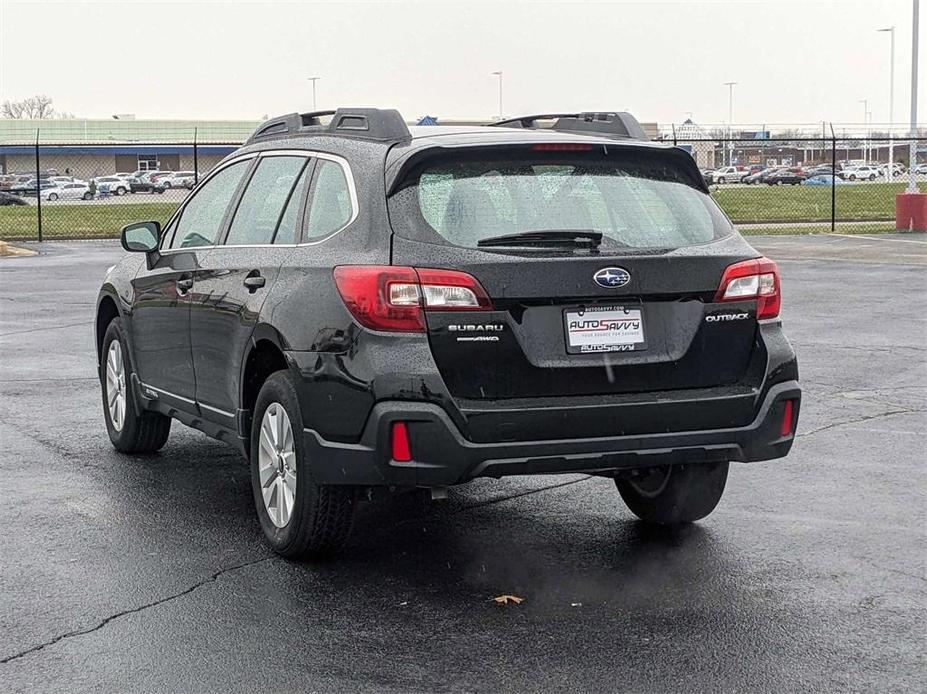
[{"left": 303, "top": 381, "right": 801, "bottom": 487}]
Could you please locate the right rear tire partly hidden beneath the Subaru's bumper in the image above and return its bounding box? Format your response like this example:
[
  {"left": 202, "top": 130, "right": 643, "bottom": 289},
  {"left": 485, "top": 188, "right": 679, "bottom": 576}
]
[{"left": 615, "top": 463, "right": 728, "bottom": 525}]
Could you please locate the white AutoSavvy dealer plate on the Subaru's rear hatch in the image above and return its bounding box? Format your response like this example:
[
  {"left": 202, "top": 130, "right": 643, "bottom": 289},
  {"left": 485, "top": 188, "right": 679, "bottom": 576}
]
[{"left": 563, "top": 306, "right": 647, "bottom": 354}]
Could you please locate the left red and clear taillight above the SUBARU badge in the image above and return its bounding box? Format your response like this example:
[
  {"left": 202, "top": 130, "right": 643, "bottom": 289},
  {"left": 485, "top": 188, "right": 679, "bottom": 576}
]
[{"left": 335, "top": 265, "right": 492, "bottom": 332}]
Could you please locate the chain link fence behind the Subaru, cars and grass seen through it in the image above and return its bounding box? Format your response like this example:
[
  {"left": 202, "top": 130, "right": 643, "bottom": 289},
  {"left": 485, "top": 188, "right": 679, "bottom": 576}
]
[{"left": 0, "top": 124, "right": 927, "bottom": 241}]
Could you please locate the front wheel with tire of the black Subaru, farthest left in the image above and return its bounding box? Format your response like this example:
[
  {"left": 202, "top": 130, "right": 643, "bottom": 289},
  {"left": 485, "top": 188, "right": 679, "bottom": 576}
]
[{"left": 100, "top": 318, "right": 171, "bottom": 453}]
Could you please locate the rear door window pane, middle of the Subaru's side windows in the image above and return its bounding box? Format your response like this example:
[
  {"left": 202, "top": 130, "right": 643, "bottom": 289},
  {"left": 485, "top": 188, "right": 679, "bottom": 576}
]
[{"left": 225, "top": 157, "right": 306, "bottom": 246}]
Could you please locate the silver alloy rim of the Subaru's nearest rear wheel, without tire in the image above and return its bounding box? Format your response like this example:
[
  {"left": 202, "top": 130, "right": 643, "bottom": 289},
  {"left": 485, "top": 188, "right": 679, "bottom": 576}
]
[{"left": 258, "top": 402, "right": 296, "bottom": 528}]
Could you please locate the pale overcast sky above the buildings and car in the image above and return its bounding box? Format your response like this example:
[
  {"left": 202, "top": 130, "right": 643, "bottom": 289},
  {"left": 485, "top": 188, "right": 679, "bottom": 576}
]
[{"left": 0, "top": 0, "right": 927, "bottom": 123}]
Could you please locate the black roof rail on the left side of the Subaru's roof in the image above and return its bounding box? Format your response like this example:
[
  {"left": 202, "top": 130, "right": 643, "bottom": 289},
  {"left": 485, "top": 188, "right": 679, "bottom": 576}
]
[{"left": 245, "top": 108, "right": 412, "bottom": 145}]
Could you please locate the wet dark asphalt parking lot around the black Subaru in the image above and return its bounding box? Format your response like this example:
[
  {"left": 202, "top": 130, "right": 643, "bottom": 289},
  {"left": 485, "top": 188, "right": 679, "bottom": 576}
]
[{"left": 0, "top": 235, "right": 927, "bottom": 692}]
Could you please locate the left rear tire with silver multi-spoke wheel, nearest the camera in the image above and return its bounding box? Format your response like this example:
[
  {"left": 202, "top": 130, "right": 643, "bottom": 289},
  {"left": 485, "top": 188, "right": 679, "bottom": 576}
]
[{"left": 251, "top": 371, "right": 354, "bottom": 558}]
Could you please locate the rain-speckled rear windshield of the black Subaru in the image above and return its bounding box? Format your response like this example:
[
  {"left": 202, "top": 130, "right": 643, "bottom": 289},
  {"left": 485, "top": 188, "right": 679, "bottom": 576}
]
[{"left": 390, "top": 147, "right": 732, "bottom": 250}]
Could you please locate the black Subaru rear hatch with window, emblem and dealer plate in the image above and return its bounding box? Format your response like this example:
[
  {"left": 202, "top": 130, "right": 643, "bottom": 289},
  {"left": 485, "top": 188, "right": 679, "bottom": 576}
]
[{"left": 389, "top": 144, "right": 762, "bottom": 433}]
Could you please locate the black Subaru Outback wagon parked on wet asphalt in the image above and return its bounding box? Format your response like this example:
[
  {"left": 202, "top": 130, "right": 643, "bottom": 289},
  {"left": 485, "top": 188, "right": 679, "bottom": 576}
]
[{"left": 96, "top": 109, "right": 801, "bottom": 556}]
